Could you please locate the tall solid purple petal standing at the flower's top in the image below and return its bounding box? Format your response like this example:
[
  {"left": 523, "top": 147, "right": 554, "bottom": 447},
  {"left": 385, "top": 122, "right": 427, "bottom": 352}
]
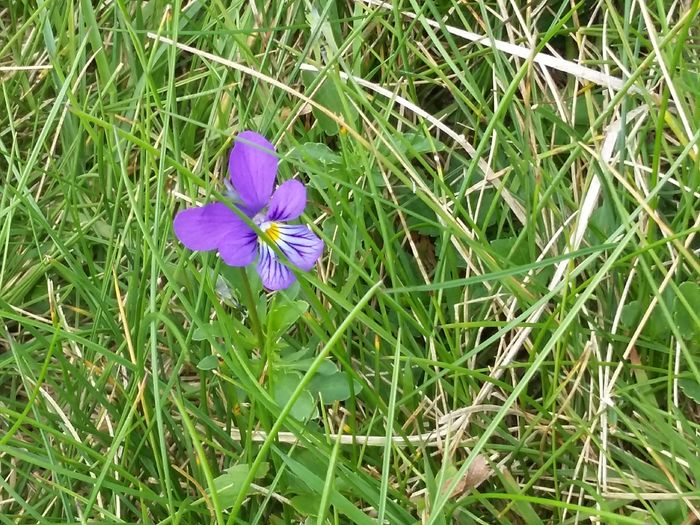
[{"left": 228, "top": 131, "right": 277, "bottom": 214}]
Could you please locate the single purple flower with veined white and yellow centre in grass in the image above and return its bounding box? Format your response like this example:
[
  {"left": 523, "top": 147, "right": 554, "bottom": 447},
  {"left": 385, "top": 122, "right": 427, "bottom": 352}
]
[{"left": 173, "top": 131, "right": 323, "bottom": 290}]
